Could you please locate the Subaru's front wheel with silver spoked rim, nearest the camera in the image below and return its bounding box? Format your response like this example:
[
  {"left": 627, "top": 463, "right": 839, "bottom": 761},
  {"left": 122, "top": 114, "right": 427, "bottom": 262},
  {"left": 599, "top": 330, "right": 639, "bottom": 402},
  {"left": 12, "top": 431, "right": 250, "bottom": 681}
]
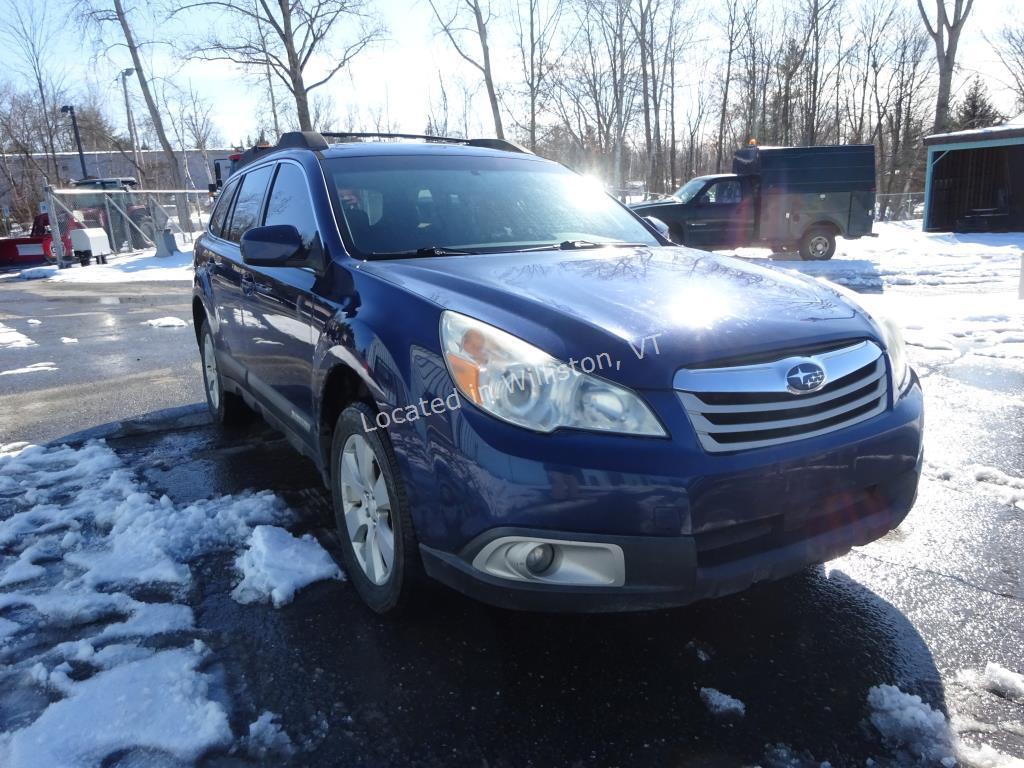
[{"left": 331, "top": 402, "right": 423, "bottom": 613}]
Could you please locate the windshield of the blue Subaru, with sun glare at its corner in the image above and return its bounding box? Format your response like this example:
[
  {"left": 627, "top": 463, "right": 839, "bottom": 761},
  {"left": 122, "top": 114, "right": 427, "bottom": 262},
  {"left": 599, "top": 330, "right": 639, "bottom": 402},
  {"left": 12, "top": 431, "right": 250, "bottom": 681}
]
[{"left": 325, "top": 155, "right": 658, "bottom": 258}]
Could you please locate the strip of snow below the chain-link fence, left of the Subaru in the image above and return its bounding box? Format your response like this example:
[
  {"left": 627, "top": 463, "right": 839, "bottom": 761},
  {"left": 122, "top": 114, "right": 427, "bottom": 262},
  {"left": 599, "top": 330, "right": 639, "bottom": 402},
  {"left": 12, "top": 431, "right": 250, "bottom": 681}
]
[{"left": 0, "top": 239, "right": 193, "bottom": 283}]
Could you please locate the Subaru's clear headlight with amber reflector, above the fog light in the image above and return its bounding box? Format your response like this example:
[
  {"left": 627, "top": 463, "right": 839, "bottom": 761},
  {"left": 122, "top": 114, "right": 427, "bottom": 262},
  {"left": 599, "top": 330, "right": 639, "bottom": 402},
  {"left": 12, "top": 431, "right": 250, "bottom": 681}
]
[{"left": 440, "top": 310, "right": 666, "bottom": 437}]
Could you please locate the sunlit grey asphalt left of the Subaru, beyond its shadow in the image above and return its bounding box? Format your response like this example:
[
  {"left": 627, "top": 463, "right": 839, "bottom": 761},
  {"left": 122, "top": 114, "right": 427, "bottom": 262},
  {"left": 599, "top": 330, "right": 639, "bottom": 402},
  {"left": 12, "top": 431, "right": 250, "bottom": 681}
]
[{"left": 0, "top": 280, "right": 203, "bottom": 442}]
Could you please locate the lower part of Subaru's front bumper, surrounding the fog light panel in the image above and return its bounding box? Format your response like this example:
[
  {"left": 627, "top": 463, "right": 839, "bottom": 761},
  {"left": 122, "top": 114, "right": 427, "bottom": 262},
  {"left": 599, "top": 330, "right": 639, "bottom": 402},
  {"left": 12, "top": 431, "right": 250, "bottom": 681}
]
[{"left": 421, "top": 459, "right": 921, "bottom": 611}]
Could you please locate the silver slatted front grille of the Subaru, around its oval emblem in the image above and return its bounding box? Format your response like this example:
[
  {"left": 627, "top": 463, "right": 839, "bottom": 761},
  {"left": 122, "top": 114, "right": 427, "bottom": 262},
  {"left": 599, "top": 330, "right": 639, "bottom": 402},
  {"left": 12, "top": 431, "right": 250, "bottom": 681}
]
[{"left": 673, "top": 341, "right": 889, "bottom": 453}]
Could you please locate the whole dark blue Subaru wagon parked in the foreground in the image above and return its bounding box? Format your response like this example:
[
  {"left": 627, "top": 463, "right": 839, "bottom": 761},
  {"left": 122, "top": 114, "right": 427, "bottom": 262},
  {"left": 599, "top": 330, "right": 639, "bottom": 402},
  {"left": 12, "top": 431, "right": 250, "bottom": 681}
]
[{"left": 193, "top": 133, "right": 923, "bottom": 612}]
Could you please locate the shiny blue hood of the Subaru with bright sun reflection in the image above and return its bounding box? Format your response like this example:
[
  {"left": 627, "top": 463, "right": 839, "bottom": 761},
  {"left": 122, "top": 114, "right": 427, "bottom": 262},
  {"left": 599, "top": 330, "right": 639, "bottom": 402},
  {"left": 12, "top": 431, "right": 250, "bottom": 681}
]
[{"left": 360, "top": 247, "right": 878, "bottom": 389}]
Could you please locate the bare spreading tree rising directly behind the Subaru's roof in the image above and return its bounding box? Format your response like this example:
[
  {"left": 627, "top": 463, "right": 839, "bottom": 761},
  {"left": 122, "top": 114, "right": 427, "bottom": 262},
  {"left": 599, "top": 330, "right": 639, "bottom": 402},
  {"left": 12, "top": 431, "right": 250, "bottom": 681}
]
[{"left": 175, "top": 0, "right": 384, "bottom": 131}]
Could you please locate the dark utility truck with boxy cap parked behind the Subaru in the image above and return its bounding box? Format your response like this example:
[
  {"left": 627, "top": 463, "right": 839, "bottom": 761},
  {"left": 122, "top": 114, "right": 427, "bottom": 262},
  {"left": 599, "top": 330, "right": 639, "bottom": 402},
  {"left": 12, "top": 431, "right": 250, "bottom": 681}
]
[{"left": 632, "top": 144, "right": 874, "bottom": 259}]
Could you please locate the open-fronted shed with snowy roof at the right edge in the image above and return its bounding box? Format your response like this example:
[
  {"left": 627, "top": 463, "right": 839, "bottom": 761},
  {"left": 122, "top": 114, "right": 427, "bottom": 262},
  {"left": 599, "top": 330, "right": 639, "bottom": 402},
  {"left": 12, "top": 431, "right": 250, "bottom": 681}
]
[{"left": 925, "top": 115, "right": 1024, "bottom": 232}]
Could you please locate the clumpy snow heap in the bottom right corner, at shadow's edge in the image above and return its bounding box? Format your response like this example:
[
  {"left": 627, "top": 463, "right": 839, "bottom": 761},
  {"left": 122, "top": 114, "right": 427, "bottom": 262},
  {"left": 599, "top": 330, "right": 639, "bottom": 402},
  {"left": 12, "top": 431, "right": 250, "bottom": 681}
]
[{"left": 867, "top": 685, "right": 1024, "bottom": 768}]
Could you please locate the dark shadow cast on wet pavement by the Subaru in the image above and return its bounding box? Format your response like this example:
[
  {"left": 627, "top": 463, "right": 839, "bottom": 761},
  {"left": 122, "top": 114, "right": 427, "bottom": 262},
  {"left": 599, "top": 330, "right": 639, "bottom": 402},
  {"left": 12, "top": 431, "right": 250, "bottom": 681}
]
[{"left": 48, "top": 414, "right": 945, "bottom": 768}]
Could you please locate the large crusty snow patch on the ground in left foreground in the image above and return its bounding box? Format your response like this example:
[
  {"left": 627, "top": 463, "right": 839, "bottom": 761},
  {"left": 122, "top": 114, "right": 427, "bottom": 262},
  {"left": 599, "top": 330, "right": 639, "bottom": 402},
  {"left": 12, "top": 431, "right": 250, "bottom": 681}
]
[{"left": 0, "top": 441, "right": 339, "bottom": 768}]
